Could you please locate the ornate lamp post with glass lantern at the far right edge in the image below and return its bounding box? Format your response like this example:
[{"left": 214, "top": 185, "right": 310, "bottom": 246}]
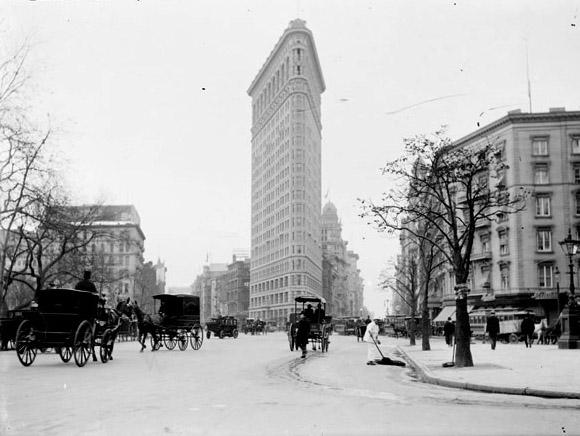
[{"left": 558, "top": 229, "right": 580, "bottom": 349}]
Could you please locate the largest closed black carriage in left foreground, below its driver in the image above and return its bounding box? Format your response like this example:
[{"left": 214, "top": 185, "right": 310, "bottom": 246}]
[{"left": 15, "top": 289, "right": 115, "bottom": 366}]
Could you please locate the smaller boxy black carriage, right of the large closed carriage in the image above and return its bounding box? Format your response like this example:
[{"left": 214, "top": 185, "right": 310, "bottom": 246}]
[{"left": 151, "top": 294, "right": 203, "bottom": 351}]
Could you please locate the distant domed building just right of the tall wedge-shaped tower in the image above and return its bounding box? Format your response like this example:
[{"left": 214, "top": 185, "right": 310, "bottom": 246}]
[{"left": 321, "top": 201, "right": 363, "bottom": 316}]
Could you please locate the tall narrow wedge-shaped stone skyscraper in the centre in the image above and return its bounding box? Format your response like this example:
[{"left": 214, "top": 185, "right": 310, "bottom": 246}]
[{"left": 248, "top": 19, "right": 325, "bottom": 328}]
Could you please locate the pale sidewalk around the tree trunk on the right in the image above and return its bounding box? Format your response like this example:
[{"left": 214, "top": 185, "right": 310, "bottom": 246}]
[{"left": 389, "top": 337, "right": 580, "bottom": 399}]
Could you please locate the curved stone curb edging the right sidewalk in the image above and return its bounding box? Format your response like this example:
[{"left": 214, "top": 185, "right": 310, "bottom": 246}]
[{"left": 396, "top": 345, "right": 580, "bottom": 400}]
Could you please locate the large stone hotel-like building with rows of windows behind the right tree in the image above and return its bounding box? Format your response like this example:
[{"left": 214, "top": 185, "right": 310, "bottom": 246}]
[{"left": 406, "top": 108, "right": 580, "bottom": 322}]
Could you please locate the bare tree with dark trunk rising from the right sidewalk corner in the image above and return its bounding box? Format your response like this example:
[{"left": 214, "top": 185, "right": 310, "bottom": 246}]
[{"left": 361, "top": 131, "right": 527, "bottom": 367}]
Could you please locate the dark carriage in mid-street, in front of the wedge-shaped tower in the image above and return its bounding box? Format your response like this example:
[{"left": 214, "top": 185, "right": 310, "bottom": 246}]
[{"left": 288, "top": 297, "right": 332, "bottom": 353}]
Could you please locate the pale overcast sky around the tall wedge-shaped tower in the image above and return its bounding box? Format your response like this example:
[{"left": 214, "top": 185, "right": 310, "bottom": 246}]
[{"left": 0, "top": 0, "right": 580, "bottom": 313}]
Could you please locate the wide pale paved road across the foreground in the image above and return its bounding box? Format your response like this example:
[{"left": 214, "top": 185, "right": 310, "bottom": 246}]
[{"left": 0, "top": 334, "right": 580, "bottom": 436}]
